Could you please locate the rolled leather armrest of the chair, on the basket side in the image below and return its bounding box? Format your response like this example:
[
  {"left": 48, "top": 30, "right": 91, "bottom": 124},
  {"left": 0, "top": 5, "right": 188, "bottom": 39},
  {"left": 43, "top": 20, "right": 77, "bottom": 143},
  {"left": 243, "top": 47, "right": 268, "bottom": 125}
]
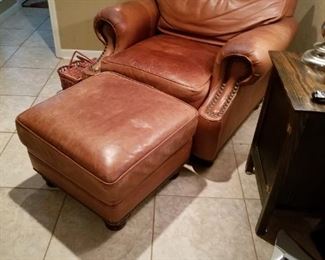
[{"left": 94, "top": 0, "right": 159, "bottom": 55}]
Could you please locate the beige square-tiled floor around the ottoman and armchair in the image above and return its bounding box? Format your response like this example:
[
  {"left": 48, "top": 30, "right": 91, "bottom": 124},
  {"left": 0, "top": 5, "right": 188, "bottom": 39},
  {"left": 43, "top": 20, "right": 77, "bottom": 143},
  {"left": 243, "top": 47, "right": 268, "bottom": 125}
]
[{"left": 0, "top": 9, "right": 272, "bottom": 260}]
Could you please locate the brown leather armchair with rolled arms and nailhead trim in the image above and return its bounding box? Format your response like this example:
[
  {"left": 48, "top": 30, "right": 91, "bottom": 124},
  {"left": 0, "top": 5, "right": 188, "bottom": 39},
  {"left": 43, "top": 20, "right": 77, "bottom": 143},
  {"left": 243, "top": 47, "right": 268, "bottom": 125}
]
[{"left": 94, "top": 0, "right": 297, "bottom": 161}]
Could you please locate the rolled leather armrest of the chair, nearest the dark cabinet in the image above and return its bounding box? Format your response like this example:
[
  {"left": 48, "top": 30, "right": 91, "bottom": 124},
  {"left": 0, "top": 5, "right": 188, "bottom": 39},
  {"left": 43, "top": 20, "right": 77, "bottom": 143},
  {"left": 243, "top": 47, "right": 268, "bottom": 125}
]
[{"left": 215, "top": 17, "right": 297, "bottom": 85}]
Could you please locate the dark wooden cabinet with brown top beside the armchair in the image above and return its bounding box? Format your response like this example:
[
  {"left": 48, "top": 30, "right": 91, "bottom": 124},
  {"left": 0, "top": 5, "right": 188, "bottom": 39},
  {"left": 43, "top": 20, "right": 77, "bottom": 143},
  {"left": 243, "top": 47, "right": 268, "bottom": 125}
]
[{"left": 246, "top": 52, "right": 325, "bottom": 235}]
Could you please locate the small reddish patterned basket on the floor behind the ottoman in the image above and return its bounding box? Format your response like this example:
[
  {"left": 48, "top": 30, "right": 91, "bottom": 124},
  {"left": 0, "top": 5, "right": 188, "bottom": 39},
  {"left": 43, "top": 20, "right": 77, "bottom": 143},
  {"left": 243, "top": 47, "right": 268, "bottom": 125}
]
[{"left": 57, "top": 51, "right": 97, "bottom": 89}]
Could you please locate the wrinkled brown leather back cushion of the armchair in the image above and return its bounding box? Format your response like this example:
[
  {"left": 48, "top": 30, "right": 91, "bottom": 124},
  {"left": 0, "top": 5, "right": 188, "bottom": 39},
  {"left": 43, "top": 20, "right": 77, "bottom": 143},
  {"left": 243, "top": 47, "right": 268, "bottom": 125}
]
[{"left": 156, "top": 0, "right": 296, "bottom": 45}]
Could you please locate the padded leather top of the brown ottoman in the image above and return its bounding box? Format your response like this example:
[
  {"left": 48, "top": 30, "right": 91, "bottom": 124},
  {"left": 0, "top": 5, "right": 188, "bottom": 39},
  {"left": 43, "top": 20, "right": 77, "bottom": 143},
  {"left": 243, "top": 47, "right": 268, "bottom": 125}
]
[{"left": 17, "top": 72, "right": 197, "bottom": 183}]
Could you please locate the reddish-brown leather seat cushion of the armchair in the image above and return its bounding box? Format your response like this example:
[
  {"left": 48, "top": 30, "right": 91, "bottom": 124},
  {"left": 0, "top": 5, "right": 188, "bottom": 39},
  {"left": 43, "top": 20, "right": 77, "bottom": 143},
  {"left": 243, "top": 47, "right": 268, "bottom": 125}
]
[{"left": 102, "top": 34, "right": 220, "bottom": 108}]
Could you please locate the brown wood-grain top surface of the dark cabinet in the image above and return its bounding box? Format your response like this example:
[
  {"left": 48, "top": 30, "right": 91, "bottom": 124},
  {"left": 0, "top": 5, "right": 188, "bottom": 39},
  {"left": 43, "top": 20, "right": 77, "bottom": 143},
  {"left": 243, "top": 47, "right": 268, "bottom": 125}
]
[{"left": 270, "top": 51, "right": 325, "bottom": 113}]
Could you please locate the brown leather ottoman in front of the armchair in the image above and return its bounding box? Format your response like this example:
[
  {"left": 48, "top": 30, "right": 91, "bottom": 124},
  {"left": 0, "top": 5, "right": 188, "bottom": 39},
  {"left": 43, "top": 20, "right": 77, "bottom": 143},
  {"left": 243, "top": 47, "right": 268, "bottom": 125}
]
[{"left": 16, "top": 72, "right": 197, "bottom": 229}]
